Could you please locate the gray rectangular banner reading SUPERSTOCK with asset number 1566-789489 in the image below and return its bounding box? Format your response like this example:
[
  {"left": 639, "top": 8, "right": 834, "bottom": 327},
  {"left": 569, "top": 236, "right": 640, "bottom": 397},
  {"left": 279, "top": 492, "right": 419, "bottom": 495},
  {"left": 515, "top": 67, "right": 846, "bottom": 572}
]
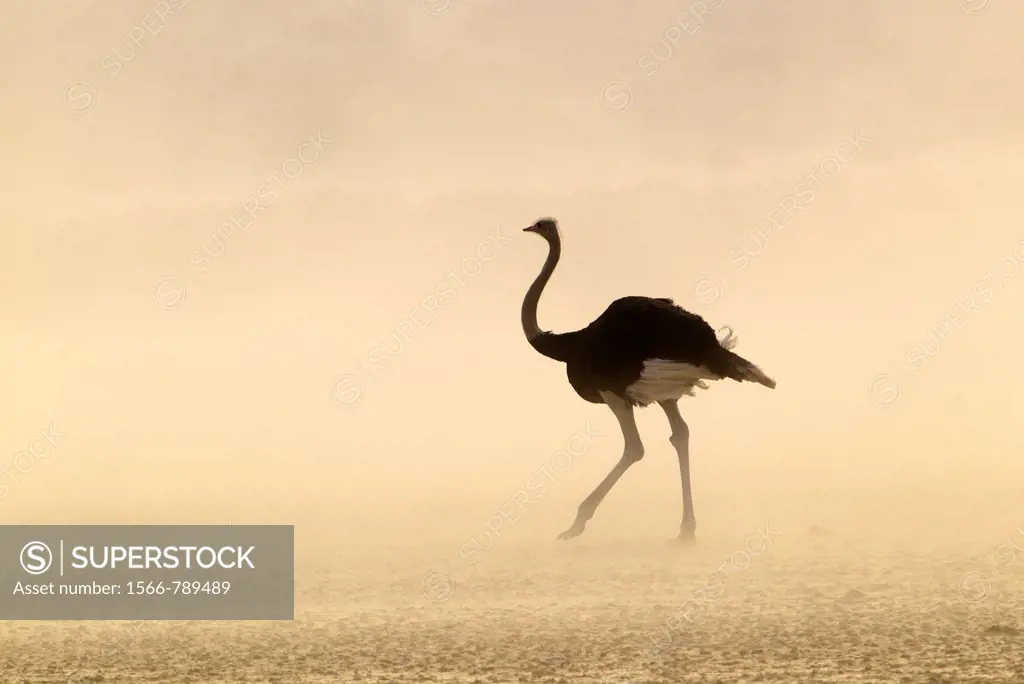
[{"left": 0, "top": 525, "right": 295, "bottom": 619}]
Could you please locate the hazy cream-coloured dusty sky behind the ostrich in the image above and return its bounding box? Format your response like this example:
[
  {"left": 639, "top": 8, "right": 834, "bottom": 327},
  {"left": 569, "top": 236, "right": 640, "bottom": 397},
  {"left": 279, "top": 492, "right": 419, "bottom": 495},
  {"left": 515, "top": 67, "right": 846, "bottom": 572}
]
[{"left": 0, "top": 0, "right": 1024, "bottom": 540}]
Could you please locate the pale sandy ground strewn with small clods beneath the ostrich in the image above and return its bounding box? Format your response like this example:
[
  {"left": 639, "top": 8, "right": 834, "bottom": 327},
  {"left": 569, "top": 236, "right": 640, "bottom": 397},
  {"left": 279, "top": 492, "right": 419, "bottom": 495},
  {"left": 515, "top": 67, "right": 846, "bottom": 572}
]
[{"left": 0, "top": 509, "right": 1024, "bottom": 684}]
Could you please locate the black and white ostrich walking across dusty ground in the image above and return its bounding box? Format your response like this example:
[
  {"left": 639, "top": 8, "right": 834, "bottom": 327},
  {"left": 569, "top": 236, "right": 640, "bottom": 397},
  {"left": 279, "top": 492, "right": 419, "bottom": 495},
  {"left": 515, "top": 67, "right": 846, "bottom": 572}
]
[{"left": 522, "top": 218, "right": 775, "bottom": 542}]
